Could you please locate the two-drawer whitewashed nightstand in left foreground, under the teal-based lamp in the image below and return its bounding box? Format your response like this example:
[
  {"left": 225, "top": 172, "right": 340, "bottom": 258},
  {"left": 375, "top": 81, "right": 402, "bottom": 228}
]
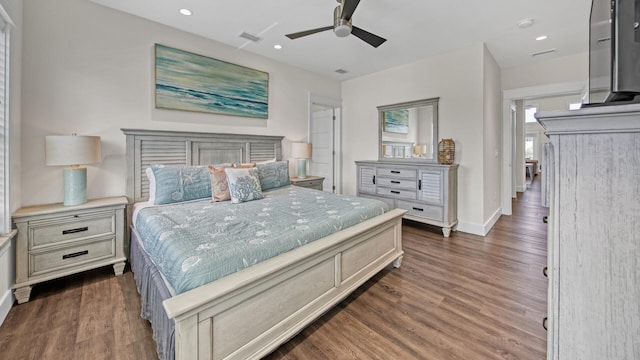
[{"left": 13, "top": 196, "right": 127, "bottom": 304}]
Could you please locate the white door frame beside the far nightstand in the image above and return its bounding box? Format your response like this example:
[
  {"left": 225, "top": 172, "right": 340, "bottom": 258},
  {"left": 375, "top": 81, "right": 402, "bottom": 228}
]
[{"left": 307, "top": 93, "right": 342, "bottom": 194}]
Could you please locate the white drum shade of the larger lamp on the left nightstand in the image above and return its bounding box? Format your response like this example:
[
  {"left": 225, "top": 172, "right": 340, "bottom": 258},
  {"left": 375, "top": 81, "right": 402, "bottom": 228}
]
[{"left": 45, "top": 135, "right": 102, "bottom": 166}]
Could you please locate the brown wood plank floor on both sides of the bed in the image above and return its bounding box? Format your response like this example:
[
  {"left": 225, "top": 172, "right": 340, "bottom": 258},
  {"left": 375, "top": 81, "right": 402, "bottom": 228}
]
[{"left": 0, "top": 178, "right": 547, "bottom": 360}]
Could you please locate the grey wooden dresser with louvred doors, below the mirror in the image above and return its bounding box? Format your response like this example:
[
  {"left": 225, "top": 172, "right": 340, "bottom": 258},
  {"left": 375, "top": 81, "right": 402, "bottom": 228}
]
[{"left": 356, "top": 161, "right": 458, "bottom": 237}]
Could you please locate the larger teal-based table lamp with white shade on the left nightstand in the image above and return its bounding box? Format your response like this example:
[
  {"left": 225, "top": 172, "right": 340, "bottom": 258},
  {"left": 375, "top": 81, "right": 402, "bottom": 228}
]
[{"left": 45, "top": 134, "right": 102, "bottom": 206}]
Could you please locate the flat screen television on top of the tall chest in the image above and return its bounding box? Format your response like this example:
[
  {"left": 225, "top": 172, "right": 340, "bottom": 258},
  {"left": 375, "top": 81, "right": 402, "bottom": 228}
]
[{"left": 585, "top": 0, "right": 640, "bottom": 106}]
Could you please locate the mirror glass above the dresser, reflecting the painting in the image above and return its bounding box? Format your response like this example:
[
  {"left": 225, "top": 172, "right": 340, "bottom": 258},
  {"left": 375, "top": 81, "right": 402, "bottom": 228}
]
[{"left": 378, "top": 98, "right": 439, "bottom": 162}]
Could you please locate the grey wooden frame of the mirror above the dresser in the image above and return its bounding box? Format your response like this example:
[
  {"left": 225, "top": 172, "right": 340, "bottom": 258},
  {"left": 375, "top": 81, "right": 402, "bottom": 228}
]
[{"left": 378, "top": 97, "right": 440, "bottom": 163}]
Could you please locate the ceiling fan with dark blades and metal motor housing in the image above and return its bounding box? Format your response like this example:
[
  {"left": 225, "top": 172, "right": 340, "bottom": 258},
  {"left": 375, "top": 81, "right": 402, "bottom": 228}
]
[{"left": 285, "top": 0, "right": 387, "bottom": 48}]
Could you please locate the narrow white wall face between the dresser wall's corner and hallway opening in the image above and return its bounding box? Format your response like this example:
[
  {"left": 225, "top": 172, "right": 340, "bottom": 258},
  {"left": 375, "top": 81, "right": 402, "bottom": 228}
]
[{"left": 482, "top": 47, "right": 502, "bottom": 231}]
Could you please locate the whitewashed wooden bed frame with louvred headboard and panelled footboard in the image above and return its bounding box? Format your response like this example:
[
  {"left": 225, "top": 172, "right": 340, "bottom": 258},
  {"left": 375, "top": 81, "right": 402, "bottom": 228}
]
[{"left": 122, "top": 129, "right": 404, "bottom": 360}]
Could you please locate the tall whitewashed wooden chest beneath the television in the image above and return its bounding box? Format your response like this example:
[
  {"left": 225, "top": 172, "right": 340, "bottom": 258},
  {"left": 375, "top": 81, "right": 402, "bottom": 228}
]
[{"left": 536, "top": 104, "right": 640, "bottom": 360}]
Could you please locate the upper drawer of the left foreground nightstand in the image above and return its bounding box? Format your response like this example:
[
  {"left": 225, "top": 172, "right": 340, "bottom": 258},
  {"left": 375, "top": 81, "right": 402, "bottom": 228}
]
[{"left": 29, "top": 211, "right": 116, "bottom": 250}]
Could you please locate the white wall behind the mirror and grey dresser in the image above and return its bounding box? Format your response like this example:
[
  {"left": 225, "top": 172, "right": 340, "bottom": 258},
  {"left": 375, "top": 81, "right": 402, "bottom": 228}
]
[{"left": 342, "top": 43, "right": 485, "bottom": 231}]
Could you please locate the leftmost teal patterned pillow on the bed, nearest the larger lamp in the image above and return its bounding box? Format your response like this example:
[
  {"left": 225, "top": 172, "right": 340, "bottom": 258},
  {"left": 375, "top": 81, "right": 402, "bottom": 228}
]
[{"left": 148, "top": 165, "right": 211, "bottom": 205}]
